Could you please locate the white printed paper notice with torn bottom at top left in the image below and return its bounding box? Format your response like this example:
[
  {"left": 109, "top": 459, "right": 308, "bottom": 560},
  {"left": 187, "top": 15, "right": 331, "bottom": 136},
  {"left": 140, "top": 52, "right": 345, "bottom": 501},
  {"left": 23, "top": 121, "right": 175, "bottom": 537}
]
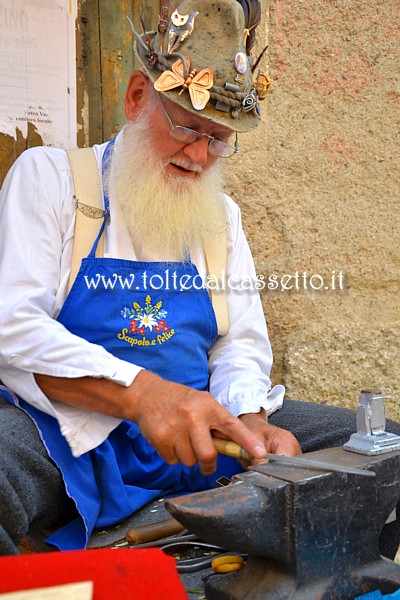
[{"left": 0, "top": 0, "right": 77, "bottom": 147}]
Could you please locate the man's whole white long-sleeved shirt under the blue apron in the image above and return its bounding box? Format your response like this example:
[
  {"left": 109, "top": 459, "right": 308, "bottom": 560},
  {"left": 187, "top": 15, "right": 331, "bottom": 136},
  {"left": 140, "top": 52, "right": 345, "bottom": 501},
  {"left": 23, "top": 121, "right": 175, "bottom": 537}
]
[{"left": 0, "top": 138, "right": 284, "bottom": 456}]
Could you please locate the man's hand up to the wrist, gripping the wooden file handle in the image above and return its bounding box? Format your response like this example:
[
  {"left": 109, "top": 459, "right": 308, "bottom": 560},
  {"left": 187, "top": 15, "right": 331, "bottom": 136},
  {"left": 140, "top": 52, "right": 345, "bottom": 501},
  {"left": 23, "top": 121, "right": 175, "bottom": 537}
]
[{"left": 126, "top": 371, "right": 266, "bottom": 475}]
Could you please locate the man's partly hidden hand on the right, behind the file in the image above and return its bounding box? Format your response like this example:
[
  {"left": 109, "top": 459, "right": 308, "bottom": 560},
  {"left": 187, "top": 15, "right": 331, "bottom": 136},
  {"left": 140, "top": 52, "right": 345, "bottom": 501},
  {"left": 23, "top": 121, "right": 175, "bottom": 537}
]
[{"left": 239, "top": 411, "right": 301, "bottom": 464}]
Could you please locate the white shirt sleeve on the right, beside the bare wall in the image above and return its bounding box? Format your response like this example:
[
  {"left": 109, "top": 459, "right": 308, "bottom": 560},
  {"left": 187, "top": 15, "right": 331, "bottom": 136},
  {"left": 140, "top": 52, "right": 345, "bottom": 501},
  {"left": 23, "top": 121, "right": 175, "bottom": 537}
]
[{"left": 209, "top": 197, "right": 285, "bottom": 416}]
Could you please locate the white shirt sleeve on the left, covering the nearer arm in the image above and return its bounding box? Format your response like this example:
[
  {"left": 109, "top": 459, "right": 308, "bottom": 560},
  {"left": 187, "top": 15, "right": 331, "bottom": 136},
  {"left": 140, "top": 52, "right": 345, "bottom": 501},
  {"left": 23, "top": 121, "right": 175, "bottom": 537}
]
[{"left": 0, "top": 147, "right": 140, "bottom": 427}]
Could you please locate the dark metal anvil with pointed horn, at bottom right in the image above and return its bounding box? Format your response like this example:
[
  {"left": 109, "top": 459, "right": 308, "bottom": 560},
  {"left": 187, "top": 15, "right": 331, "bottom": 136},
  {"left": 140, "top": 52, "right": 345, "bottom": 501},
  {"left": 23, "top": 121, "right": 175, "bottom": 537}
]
[{"left": 166, "top": 448, "right": 400, "bottom": 600}]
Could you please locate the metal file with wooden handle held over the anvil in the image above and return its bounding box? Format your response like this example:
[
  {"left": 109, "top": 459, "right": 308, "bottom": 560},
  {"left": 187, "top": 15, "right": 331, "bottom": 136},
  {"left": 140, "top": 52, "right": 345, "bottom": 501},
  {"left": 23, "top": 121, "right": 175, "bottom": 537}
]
[{"left": 213, "top": 438, "right": 375, "bottom": 477}]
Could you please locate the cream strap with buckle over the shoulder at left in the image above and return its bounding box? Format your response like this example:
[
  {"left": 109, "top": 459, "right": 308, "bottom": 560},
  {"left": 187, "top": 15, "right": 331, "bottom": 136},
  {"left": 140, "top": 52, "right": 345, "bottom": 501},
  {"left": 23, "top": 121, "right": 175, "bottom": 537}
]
[{"left": 67, "top": 148, "right": 105, "bottom": 291}]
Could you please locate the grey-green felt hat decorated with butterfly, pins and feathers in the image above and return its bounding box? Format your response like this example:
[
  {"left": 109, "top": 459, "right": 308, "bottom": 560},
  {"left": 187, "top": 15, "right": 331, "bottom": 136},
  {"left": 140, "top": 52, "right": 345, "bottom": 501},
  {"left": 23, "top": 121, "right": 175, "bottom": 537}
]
[{"left": 134, "top": 0, "right": 269, "bottom": 132}]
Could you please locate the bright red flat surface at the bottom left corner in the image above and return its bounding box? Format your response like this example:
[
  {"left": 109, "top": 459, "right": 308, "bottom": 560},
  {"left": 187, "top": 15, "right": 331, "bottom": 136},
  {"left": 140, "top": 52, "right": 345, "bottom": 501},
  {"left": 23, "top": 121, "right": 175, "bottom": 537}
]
[{"left": 0, "top": 548, "right": 187, "bottom": 600}]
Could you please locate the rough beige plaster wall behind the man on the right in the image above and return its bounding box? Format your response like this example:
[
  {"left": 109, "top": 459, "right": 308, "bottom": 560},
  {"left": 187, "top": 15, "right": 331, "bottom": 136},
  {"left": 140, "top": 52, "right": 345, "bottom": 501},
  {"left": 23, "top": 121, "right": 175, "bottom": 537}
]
[{"left": 227, "top": 0, "right": 400, "bottom": 419}]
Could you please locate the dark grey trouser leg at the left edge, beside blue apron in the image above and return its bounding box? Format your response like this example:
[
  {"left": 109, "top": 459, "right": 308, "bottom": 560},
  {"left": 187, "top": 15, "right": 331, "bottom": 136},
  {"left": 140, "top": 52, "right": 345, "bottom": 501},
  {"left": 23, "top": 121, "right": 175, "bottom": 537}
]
[{"left": 0, "top": 397, "right": 76, "bottom": 555}]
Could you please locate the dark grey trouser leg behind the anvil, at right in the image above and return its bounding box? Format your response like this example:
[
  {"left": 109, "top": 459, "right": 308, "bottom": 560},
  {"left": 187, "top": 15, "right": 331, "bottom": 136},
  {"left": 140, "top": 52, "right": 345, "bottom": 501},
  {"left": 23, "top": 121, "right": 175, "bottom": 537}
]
[{"left": 268, "top": 399, "right": 400, "bottom": 559}]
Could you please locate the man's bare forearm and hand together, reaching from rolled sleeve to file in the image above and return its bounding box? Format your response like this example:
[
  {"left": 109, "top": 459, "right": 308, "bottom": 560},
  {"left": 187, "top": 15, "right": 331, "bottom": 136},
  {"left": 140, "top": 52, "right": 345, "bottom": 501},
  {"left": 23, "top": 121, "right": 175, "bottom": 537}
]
[{"left": 35, "top": 370, "right": 266, "bottom": 475}]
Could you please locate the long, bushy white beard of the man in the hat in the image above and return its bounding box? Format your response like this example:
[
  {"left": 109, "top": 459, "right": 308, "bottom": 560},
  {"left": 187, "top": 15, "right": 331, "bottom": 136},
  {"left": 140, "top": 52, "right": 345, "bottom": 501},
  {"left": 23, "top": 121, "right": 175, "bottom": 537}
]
[{"left": 106, "top": 113, "right": 226, "bottom": 262}]
